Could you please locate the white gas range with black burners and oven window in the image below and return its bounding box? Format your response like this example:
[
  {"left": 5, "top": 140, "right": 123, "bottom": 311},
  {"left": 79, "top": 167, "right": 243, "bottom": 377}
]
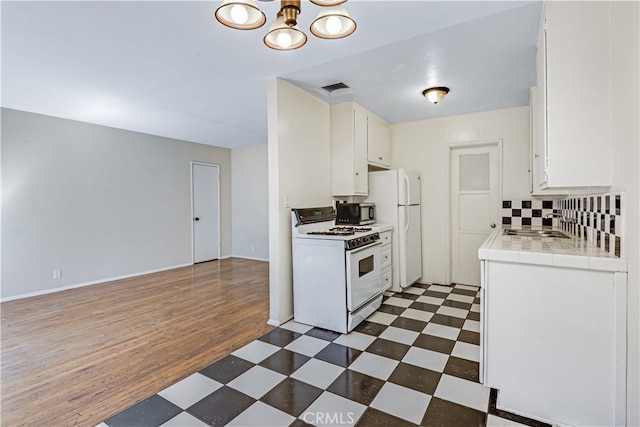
[{"left": 291, "top": 206, "right": 382, "bottom": 333}]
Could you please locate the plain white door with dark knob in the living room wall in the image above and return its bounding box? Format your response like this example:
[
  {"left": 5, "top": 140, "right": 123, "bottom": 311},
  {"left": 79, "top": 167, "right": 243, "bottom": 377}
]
[{"left": 191, "top": 163, "right": 220, "bottom": 262}]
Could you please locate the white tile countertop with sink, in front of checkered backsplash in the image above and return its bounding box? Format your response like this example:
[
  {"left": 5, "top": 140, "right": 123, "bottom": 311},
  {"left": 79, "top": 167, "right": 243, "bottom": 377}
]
[{"left": 478, "top": 227, "right": 627, "bottom": 272}]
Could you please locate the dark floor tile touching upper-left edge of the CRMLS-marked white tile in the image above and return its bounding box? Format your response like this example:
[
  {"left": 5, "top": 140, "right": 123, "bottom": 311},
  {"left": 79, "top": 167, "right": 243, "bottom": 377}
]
[{"left": 260, "top": 378, "right": 322, "bottom": 417}]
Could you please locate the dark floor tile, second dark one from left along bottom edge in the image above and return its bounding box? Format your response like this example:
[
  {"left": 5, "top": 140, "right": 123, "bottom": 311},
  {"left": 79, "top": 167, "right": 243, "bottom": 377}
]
[{"left": 187, "top": 386, "right": 256, "bottom": 426}]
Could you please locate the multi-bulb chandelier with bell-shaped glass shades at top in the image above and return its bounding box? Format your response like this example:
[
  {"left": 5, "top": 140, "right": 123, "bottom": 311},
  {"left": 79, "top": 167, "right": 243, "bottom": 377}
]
[{"left": 215, "top": 0, "right": 356, "bottom": 50}]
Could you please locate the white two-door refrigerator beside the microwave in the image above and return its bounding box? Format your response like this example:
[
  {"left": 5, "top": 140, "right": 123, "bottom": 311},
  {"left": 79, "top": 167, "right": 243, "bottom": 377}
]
[{"left": 367, "top": 169, "right": 422, "bottom": 292}]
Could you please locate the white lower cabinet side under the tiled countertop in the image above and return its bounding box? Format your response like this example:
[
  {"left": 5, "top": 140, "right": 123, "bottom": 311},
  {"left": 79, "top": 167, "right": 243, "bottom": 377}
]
[{"left": 481, "top": 260, "right": 627, "bottom": 426}]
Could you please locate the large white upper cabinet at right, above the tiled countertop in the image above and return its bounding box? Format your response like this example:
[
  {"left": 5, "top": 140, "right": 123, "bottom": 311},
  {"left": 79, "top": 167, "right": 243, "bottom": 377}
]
[{"left": 532, "top": 1, "right": 612, "bottom": 194}]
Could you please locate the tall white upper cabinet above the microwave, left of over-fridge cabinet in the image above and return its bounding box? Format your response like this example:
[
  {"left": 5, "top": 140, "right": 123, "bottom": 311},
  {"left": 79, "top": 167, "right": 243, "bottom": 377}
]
[{"left": 331, "top": 102, "right": 369, "bottom": 196}]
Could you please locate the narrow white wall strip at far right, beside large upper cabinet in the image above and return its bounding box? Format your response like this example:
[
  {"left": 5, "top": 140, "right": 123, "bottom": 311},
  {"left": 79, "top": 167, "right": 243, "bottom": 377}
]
[{"left": 611, "top": 1, "right": 640, "bottom": 426}]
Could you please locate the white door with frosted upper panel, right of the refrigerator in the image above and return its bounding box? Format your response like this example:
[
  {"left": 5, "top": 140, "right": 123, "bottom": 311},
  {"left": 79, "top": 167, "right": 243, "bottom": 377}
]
[{"left": 449, "top": 142, "right": 502, "bottom": 286}]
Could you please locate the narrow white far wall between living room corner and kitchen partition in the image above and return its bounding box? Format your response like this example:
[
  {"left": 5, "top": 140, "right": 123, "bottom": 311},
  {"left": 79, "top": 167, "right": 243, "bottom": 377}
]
[{"left": 231, "top": 144, "right": 269, "bottom": 261}]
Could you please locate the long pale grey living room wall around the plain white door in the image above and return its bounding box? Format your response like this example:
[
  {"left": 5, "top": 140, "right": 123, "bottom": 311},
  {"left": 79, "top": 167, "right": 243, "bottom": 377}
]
[{"left": 0, "top": 109, "right": 231, "bottom": 299}]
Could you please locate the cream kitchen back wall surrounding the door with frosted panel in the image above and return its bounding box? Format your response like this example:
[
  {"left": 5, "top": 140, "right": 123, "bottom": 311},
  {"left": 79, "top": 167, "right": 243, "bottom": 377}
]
[{"left": 391, "top": 107, "right": 530, "bottom": 283}]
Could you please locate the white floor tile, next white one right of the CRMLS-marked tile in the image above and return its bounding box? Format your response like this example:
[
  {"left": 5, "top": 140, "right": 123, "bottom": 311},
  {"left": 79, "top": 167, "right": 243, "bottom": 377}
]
[{"left": 371, "top": 383, "right": 431, "bottom": 424}]
